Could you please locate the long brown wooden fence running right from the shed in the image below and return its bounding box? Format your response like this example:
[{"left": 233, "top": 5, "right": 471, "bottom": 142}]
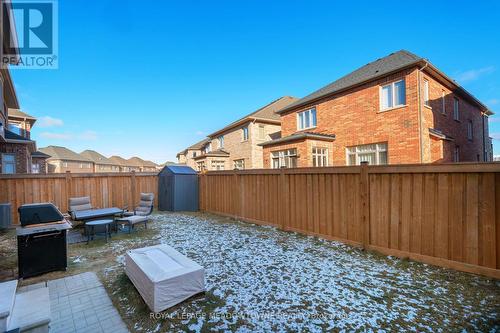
[{"left": 200, "top": 163, "right": 500, "bottom": 278}]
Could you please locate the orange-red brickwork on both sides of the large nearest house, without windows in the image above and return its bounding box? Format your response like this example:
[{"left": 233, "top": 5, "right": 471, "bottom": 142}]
[{"left": 270, "top": 68, "right": 488, "bottom": 168}]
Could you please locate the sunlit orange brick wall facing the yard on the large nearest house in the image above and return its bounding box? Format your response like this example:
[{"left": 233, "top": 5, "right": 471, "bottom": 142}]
[{"left": 281, "top": 69, "right": 420, "bottom": 165}]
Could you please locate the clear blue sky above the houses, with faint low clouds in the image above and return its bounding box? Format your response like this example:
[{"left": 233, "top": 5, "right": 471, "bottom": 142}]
[{"left": 12, "top": 0, "right": 500, "bottom": 162}]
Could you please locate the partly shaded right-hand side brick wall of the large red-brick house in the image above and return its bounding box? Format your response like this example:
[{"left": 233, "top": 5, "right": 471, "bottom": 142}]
[{"left": 422, "top": 73, "right": 488, "bottom": 163}]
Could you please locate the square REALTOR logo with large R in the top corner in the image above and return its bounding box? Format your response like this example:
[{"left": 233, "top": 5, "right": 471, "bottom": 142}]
[{"left": 2, "top": 0, "right": 58, "bottom": 69}]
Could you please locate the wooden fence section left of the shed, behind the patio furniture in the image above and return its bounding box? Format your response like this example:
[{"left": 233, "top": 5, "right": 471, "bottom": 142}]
[{"left": 0, "top": 172, "right": 158, "bottom": 225}]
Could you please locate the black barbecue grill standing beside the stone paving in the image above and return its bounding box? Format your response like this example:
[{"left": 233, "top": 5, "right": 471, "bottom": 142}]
[{"left": 16, "top": 203, "right": 71, "bottom": 278}]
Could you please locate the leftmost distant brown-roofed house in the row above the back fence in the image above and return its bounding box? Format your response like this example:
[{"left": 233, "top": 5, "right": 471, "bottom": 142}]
[{"left": 40, "top": 146, "right": 94, "bottom": 173}]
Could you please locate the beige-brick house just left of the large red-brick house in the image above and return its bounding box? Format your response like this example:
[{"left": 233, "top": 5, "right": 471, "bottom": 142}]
[{"left": 188, "top": 96, "right": 298, "bottom": 171}]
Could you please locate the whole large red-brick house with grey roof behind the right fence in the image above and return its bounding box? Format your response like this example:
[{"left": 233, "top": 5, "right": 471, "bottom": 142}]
[{"left": 260, "top": 50, "right": 492, "bottom": 168}]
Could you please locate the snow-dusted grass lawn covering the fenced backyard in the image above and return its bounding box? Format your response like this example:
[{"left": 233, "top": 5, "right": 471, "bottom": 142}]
[{"left": 0, "top": 213, "right": 500, "bottom": 332}]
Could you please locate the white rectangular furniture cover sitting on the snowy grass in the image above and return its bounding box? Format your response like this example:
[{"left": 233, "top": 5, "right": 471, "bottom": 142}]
[{"left": 125, "top": 245, "right": 205, "bottom": 312}]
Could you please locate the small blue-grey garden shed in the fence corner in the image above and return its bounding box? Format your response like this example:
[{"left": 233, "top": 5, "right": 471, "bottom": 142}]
[{"left": 158, "top": 165, "right": 198, "bottom": 212}]
